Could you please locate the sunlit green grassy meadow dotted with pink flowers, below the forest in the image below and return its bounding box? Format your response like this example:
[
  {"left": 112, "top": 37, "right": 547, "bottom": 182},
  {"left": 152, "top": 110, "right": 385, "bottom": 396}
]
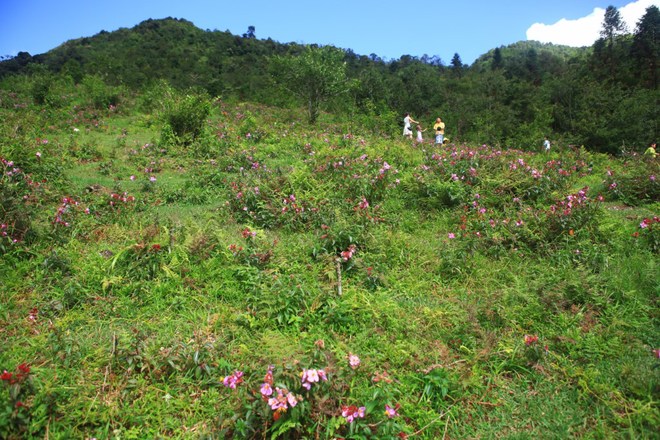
[{"left": 0, "top": 87, "right": 660, "bottom": 439}]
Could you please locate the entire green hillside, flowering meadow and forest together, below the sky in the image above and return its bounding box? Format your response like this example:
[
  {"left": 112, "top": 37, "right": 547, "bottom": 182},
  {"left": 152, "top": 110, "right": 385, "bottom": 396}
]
[{"left": 0, "top": 8, "right": 660, "bottom": 440}]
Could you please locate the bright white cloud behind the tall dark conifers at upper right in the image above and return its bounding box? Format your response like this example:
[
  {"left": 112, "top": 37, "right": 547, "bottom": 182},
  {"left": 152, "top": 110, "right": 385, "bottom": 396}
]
[{"left": 527, "top": 0, "right": 660, "bottom": 47}]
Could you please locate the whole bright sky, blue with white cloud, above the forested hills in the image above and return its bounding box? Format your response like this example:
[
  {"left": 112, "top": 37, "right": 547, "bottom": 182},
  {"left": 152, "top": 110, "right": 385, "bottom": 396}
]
[{"left": 0, "top": 0, "right": 660, "bottom": 63}]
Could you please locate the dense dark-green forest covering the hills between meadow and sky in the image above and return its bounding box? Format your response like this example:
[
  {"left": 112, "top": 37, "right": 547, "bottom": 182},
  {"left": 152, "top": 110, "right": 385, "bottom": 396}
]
[{"left": 0, "top": 6, "right": 660, "bottom": 154}]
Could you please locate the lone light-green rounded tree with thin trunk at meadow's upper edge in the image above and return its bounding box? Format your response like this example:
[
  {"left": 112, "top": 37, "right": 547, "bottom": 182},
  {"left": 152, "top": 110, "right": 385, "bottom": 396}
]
[{"left": 271, "top": 46, "right": 350, "bottom": 124}]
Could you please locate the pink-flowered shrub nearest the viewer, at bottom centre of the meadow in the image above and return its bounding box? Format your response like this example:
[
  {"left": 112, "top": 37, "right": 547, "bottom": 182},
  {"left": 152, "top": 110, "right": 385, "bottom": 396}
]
[{"left": 222, "top": 352, "right": 402, "bottom": 438}]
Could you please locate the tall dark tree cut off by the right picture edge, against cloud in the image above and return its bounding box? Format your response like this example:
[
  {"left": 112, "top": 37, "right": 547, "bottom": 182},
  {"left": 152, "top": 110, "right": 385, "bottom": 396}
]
[{"left": 631, "top": 6, "right": 660, "bottom": 89}]
